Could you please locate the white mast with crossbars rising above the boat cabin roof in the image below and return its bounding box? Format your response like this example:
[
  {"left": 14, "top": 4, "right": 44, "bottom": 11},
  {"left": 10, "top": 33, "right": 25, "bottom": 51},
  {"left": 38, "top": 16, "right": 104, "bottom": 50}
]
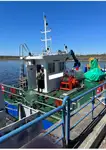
[{"left": 41, "top": 15, "right": 51, "bottom": 53}]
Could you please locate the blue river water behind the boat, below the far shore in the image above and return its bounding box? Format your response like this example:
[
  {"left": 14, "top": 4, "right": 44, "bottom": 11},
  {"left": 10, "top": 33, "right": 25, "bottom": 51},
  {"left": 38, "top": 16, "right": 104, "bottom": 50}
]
[{"left": 0, "top": 60, "right": 106, "bottom": 84}]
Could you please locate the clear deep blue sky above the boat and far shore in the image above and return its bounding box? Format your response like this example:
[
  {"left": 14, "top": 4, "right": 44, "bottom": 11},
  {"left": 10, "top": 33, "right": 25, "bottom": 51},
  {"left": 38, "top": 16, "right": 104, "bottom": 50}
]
[{"left": 0, "top": 1, "right": 106, "bottom": 55}]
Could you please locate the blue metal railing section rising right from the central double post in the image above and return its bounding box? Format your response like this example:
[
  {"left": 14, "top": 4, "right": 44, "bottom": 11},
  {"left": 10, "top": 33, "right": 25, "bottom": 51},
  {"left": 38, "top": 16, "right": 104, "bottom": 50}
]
[{"left": 66, "top": 81, "right": 106, "bottom": 144}]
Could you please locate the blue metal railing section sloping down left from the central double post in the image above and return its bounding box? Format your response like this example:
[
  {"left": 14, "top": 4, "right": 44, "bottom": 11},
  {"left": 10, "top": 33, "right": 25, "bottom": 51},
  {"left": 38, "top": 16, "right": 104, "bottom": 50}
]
[{"left": 0, "top": 97, "right": 68, "bottom": 147}]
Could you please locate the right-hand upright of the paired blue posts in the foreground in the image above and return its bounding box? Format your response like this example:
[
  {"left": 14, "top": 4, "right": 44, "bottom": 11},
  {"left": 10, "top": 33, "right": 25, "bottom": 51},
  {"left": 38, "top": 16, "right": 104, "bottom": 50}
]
[{"left": 66, "top": 98, "right": 70, "bottom": 146}]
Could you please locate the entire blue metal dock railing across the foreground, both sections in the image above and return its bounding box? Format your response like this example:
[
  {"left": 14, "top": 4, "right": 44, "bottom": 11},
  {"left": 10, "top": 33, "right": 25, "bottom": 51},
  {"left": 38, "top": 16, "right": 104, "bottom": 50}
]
[{"left": 0, "top": 82, "right": 106, "bottom": 147}]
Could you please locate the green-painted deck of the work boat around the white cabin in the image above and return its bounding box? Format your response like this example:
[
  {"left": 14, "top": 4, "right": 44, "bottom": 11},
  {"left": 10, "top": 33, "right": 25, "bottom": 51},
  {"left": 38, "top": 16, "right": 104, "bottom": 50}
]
[{"left": 1, "top": 81, "right": 99, "bottom": 122}]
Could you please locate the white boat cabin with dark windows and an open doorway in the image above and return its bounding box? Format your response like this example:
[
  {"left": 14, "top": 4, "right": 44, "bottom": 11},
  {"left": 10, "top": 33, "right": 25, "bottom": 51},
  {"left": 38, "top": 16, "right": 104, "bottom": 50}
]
[{"left": 26, "top": 53, "right": 68, "bottom": 93}]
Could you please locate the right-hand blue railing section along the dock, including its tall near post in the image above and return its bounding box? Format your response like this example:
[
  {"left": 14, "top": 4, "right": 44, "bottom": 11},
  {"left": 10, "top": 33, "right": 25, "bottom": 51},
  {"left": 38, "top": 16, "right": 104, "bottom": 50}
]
[{"left": 66, "top": 81, "right": 106, "bottom": 145}]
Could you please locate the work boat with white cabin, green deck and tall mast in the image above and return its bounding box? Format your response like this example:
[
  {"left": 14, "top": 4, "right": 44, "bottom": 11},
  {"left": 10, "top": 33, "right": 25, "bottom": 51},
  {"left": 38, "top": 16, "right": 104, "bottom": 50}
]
[{"left": 0, "top": 16, "right": 105, "bottom": 148}]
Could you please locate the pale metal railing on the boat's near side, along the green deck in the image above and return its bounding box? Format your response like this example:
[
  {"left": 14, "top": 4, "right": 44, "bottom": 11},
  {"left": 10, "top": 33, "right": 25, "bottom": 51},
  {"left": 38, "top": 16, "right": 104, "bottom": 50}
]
[{"left": 0, "top": 84, "right": 62, "bottom": 120}]
